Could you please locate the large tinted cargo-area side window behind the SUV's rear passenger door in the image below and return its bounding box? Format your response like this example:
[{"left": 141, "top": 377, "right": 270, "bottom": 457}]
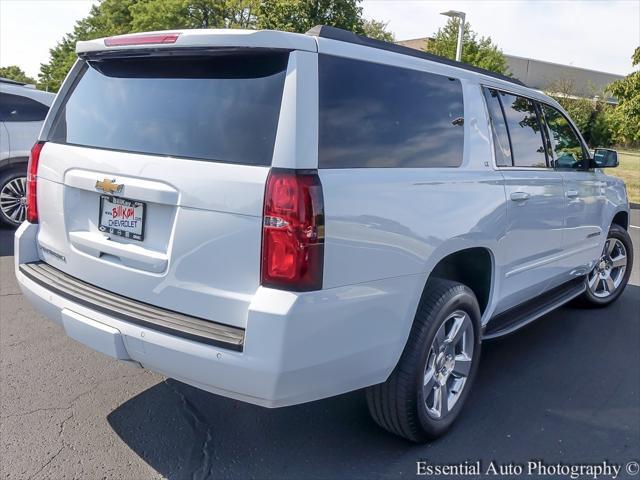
[{"left": 319, "top": 55, "right": 464, "bottom": 168}]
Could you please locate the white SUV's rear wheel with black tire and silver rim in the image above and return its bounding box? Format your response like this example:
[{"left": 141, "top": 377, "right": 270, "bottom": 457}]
[{"left": 367, "top": 278, "right": 481, "bottom": 442}]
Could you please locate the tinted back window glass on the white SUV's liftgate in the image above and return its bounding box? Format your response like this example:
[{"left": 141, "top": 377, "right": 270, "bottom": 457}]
[{"left": 49, "top": 52, "right": 289, "bottom": 165}]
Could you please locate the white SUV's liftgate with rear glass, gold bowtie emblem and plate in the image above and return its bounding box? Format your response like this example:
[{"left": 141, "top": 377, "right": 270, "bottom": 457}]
[{"left": 38, "top": 49, "right": 289, "bottom": 326}]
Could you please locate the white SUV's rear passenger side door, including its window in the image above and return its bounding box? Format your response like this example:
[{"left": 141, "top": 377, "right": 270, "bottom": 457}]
[{"left": 485, "top": 89, "right": 564, "bottom": 312}]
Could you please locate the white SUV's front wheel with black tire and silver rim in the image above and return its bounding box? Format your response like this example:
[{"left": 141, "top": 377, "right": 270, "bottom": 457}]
[{"left": 578, "top": 224, "right": 633, "bottom": 307}]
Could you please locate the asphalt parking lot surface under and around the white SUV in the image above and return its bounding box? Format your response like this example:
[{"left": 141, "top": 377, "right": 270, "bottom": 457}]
[{"left": 0, "top": 210, "right": 640, "bottom": 479}]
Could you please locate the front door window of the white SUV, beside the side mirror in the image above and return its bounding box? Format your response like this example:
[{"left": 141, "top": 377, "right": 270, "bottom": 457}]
[{"left": 540, "top": 103, "right": 586, "bottom": 169}]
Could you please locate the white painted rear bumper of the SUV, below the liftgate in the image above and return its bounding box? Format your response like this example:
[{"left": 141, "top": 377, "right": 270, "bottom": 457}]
[{"left": 15, "top": 223, "right": 424, "bottom": 407}]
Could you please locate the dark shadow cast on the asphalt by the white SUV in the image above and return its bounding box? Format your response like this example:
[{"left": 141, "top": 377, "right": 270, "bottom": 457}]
[{"left": 108, "top": 285, "right": 640, "bottom": 479}]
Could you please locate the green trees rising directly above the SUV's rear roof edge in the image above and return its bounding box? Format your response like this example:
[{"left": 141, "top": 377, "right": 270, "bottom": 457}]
[{"left": 39, "top": 0, "right": 393, "bottom": 92}]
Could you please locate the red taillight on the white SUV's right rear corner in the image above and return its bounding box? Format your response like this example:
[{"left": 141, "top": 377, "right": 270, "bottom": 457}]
[{"left": 262, "top": 168, "right": 324, "bottom": 291}]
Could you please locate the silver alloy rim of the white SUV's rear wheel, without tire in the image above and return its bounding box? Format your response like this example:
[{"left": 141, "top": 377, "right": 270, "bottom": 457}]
[{"left": 422, "top": 310, "right": 475, "bottom": 420}]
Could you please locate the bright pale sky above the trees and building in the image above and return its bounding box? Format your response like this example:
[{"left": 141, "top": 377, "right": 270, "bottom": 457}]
[{"left": 0, "top": 0, "right": 640, "bottom": 77}]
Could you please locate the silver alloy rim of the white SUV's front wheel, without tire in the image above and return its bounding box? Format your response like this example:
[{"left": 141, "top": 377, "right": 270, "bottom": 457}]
[{"left": 587, "top": 238, "right": 627, "bottom": 298}]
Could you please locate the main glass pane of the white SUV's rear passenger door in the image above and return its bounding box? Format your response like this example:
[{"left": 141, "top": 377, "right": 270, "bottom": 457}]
[{"left": 500, "top": 92, "right": 547, "bottom": 167}]
